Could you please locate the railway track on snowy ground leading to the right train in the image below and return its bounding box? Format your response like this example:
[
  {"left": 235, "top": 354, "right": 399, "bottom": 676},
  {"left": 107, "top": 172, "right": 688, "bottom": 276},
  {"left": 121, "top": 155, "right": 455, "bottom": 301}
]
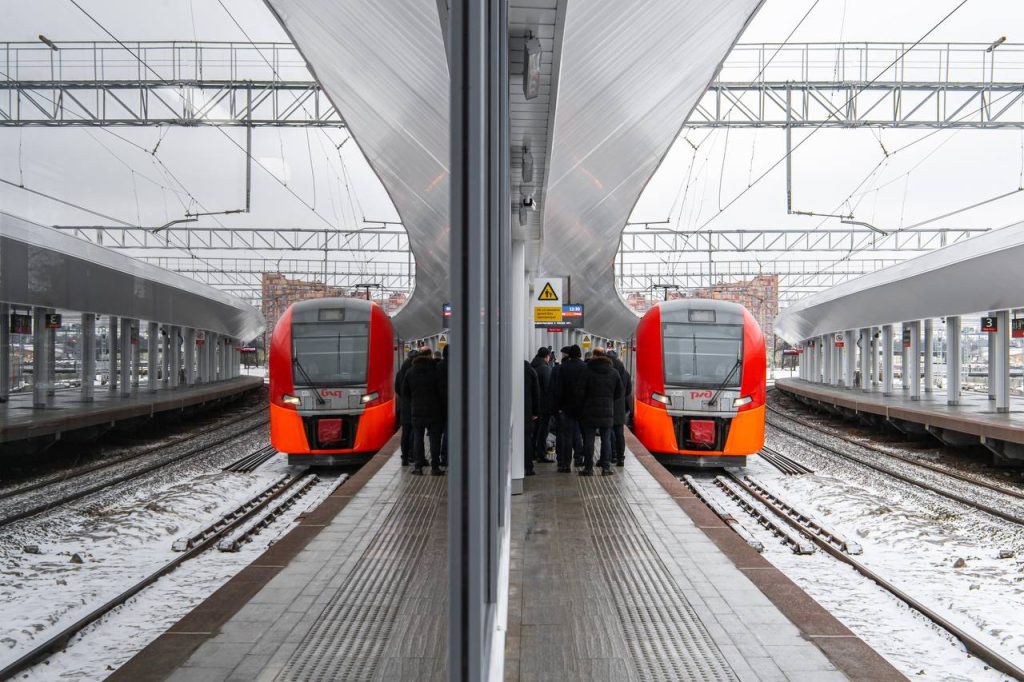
[{"left": 712, "top": 471, "right": 1024, "bottom": 680}]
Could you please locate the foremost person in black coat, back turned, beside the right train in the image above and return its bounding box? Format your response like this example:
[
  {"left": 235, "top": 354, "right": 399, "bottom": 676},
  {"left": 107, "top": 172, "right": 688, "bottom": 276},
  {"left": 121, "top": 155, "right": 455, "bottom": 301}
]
[{"left": 577, "top": 348, "right": 623, "bottom": 476}]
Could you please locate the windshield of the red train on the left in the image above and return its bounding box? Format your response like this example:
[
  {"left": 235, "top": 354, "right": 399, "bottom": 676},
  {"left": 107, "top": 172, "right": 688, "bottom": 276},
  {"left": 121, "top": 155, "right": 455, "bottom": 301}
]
[{"left": 292, "top": 322, "right": 370, "bottom": 386}]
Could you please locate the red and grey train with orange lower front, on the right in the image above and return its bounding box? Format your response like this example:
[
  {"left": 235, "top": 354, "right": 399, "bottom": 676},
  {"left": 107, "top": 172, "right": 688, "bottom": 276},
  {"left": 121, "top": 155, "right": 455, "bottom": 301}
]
[{"left": 633, "top": 299, "right": 767, "bottom": 467}]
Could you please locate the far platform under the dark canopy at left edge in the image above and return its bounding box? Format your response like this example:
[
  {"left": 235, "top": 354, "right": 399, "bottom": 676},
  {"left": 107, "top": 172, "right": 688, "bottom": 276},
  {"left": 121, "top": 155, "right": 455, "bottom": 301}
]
[{"left": 0, "top": 376, "right": 263, "bottom": 454}]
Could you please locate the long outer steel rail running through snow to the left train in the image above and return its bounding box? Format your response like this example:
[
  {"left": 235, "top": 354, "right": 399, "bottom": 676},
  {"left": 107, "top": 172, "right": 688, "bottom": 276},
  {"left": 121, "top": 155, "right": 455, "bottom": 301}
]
[{"left": 0, "top": 469, "right": 308, "bottom": 680}]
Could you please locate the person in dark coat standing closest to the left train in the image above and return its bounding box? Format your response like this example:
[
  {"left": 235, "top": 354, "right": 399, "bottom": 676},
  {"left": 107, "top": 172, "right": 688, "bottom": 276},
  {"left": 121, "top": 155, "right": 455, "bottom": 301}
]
[{"left": 401, "top": 348, "right": 447, "bottom": 476}]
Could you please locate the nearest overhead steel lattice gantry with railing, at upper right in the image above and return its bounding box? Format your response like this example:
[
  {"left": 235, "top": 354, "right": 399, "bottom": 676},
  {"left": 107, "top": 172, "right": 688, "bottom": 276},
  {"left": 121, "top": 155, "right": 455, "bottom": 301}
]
[{"left": 687, "top": 43, "right": 1024, "bottom": 128}]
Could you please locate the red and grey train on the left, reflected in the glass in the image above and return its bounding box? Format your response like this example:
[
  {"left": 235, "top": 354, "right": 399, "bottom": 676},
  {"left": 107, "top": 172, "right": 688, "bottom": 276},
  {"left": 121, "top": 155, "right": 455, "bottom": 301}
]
[{"left": 270, "top": 298, "right": 395, "bottom": 465}]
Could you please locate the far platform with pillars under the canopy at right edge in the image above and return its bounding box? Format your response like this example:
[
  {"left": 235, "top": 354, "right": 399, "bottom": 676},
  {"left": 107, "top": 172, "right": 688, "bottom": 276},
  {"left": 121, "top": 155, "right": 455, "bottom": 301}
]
[{"left": 775, "top": 378, "right": 1024, "bottom": 463}]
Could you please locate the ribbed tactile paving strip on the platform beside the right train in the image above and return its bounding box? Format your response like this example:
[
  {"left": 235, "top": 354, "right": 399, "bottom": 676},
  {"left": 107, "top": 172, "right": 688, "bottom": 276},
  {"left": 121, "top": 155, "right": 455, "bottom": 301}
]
[{"left": 580, "top": 476, "right": 737, "bottom": 680}]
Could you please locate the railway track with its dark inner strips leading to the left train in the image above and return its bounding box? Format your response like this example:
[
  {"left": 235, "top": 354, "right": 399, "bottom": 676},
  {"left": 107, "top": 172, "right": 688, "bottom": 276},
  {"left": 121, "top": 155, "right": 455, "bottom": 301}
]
[{"left": 0, "top": 468, "right": 315, "bottom": 680}]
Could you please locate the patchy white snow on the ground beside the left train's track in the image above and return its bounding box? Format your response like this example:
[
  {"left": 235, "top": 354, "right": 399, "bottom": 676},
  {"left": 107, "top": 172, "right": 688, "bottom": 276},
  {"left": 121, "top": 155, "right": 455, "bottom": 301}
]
[{"left": 0, "top": 419, "right": 337, "bottom": 679}]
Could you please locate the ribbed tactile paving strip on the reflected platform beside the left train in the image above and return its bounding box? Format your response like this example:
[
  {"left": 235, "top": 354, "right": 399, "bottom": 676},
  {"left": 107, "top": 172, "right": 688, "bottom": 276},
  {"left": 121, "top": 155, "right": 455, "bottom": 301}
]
[{"left": 276, "top": 477, "right": 446, "bottom": 682}]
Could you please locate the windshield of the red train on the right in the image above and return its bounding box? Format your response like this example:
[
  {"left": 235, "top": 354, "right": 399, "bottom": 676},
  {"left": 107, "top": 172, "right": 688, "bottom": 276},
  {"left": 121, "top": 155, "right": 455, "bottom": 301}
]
[{"left": 664, "top": 323, "right": 743, "bottom": 388}]
